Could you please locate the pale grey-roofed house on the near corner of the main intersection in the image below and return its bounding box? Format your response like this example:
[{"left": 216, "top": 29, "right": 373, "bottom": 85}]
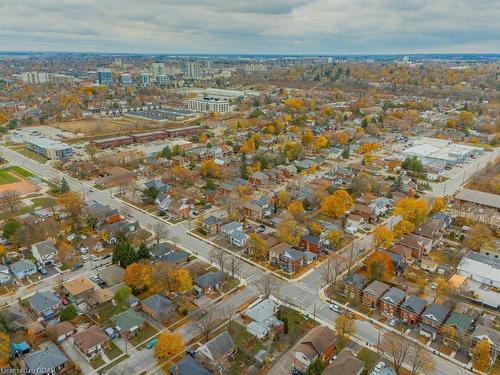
[{"left": 243, "top": 298, "right": 283, "bottom": 339}]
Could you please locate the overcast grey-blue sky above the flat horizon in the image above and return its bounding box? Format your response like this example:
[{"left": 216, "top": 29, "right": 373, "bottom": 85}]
[{"left": 0, "top": 0, "right": 500, "bottom": 54}]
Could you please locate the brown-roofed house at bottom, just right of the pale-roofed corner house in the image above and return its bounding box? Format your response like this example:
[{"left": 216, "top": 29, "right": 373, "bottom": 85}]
[{"left": 293, "top": 326, "right": 337, "bottom": 372}]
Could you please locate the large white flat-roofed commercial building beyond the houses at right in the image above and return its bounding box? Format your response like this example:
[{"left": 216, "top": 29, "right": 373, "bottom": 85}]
[{"left": 401, "top": 137, "right": 484, "bottom": 169}]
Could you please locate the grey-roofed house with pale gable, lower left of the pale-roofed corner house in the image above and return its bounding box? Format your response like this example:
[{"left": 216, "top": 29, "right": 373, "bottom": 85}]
[{"left": 196, "top": 331, "right": 238, "bottom": 370}]
